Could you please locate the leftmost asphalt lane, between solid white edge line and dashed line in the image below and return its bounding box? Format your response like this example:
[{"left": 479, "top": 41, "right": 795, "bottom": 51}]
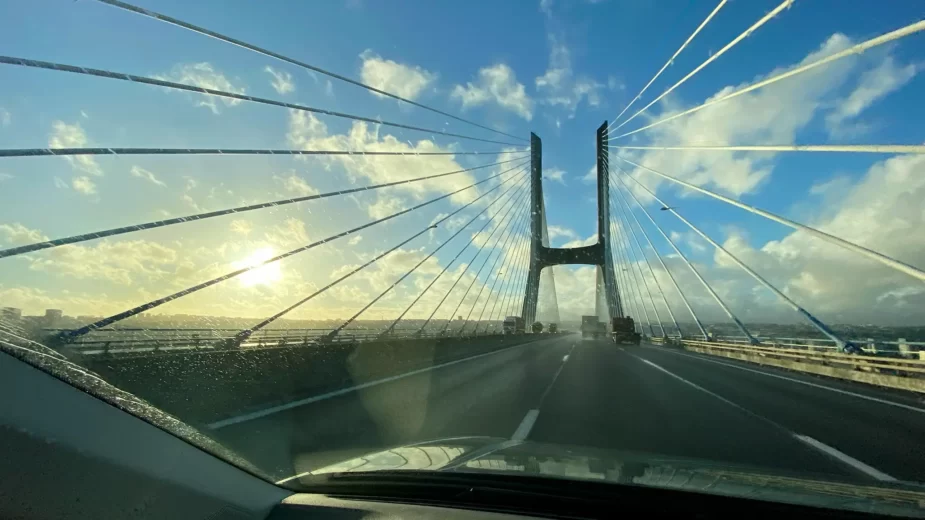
[{"left": 207, "top": 336, "right": 574, "bottom": 479}]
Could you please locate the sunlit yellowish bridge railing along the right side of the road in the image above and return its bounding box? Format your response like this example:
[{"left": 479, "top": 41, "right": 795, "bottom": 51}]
[{"left": 652, "top": 338, "right": 925, "bottom": 393}]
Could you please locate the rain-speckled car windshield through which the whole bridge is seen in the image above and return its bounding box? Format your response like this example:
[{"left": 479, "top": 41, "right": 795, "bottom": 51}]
[{"left": 0, "top": 0, "right": 925, "bottom": 507}]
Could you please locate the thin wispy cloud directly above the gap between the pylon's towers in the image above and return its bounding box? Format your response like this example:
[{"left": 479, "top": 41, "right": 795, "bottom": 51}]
[{"left": 535, "top": 35, "right": 604, "bottom": 118}]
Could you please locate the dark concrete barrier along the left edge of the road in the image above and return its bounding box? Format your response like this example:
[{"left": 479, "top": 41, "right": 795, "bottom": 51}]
[{"left": 78, "top": 334, "right": 549, "bottom": 425}]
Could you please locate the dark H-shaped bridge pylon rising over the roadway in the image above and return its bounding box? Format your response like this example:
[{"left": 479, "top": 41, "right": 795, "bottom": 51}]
[{"left": 521, "top": 121, "right": 623, "bottom": 325}]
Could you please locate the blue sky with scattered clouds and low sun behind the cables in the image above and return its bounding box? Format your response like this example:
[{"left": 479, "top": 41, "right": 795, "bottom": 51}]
[{"left": 0, "top": 0, "right": 925, "bottom": 325}]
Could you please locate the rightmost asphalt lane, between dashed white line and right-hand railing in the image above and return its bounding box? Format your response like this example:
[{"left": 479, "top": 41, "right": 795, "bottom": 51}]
[{"left": 627, "top": 347, "right": 925, "bottom": 482}]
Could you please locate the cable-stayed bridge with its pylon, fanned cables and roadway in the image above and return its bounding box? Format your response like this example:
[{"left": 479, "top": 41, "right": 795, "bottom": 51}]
[{"left": 0, "top": 0, "right": 925, "bottom": 488}]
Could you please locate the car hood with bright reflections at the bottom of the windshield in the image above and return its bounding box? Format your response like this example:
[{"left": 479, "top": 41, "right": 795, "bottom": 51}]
[{"left": 310, "top": 437, "right": 925, "bottom": 517}]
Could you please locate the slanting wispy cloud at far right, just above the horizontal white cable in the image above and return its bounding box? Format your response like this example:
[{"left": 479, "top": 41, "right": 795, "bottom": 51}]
[{"left": 826, "top": 56, "right": 919, "bottom": 135}]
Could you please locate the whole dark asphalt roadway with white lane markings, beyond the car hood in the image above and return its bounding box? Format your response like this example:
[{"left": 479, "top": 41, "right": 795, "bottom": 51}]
[{"left": 211, "top": 335, "right": 925, "bottom": 482}]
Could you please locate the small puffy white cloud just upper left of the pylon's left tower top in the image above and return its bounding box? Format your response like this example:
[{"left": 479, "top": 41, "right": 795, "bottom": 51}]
[{"left": 450, "top": 63, "right": 533, "bottom": 121}]
